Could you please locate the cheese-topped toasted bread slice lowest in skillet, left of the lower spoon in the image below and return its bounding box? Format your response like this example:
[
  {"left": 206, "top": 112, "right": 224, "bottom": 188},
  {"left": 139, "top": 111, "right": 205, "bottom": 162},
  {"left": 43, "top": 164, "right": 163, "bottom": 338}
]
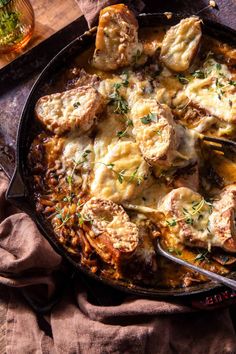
[{"left": 82, "top": 198, "right": 139, "bottom": 264}]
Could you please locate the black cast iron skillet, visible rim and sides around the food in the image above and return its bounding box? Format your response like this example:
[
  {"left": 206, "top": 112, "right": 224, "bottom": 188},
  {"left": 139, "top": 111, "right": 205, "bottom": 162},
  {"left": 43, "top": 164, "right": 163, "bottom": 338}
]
[{"left": 6, "top": 14, "right": 236, "bottom": 298}]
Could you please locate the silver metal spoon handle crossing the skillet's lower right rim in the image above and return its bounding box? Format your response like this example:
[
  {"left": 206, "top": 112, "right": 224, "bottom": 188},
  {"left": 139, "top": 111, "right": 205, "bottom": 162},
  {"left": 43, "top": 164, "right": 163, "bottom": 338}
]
[{"left": 157, "top": 240, "right": 236, "bottom": 290}]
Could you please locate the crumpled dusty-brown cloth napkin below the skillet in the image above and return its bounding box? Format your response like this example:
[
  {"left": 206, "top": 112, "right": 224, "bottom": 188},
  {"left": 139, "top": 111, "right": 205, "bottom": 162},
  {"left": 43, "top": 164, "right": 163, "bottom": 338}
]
[{"left": 0, "top": 172, "right": 236, "bottom": 354}]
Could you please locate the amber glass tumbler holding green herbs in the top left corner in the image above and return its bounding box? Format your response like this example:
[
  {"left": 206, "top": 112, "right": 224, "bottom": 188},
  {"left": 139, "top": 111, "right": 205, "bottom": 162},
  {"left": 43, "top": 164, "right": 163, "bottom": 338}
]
[{"left": 0, "top": 0, "right": 34, "bottom": 54}]
